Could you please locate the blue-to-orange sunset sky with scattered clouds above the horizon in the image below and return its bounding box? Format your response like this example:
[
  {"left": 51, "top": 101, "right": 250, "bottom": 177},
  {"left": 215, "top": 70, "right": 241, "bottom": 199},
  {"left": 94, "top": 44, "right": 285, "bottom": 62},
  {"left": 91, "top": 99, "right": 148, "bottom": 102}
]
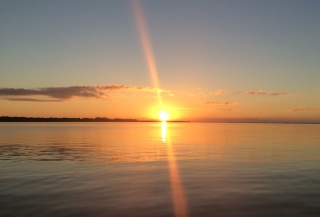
[{"left": 0, "top": 0, "right": 320, "bottom": 122}]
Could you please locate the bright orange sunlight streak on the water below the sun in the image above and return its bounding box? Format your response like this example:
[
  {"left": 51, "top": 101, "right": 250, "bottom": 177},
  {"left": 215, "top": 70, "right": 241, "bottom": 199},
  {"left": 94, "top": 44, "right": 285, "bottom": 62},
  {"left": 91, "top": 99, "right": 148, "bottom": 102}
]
[{"left": 161, "top": 121, "right": 188, "bottom": 217}]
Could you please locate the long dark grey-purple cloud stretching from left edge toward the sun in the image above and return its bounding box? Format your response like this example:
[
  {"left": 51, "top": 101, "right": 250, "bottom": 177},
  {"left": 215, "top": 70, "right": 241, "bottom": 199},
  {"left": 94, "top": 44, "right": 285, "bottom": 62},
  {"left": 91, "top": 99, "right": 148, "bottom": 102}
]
[{"left": 0, "top": 85, "right": 172, "bottom": 102}]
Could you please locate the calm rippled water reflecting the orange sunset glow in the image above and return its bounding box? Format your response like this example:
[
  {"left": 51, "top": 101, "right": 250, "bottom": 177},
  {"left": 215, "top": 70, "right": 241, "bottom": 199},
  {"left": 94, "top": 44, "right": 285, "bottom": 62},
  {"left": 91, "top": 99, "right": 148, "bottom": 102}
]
[{"left": 0, "top": 123, "right": 320, "bottom": 217}]
